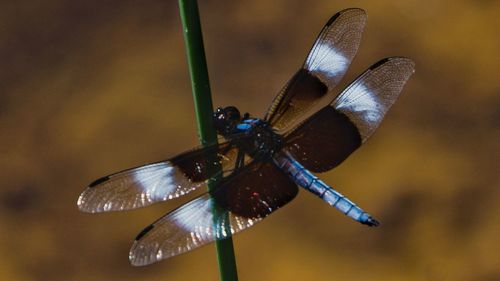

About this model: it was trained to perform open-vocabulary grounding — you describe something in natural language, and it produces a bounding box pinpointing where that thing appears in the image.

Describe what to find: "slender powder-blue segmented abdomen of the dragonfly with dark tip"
[274,153,379,226]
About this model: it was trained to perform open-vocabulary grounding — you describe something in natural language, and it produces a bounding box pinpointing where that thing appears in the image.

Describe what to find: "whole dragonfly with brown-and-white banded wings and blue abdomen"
[77,8,415,266]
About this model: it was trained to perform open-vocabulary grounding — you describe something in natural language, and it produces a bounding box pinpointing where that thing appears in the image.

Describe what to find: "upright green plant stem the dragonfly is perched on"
[179,0,238,281]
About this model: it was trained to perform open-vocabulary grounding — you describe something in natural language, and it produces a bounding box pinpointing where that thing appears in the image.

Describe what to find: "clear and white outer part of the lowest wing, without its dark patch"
[129,193,260,266]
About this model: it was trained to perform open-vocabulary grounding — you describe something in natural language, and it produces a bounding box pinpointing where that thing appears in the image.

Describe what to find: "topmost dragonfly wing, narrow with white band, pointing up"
[265,8,366,130]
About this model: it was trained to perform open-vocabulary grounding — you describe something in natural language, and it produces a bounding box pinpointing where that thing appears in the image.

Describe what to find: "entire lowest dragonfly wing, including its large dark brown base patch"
[129,162,298,266]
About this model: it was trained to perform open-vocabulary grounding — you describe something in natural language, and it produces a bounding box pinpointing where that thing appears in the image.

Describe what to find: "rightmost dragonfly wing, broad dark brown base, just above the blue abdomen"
[286,57,415,172]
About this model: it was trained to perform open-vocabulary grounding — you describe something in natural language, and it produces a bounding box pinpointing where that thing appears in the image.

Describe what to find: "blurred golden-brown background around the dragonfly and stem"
[0,0,500,281]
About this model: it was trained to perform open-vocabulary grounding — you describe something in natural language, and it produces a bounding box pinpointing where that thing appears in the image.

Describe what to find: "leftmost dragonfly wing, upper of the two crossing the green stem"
[77,142,237,213]
